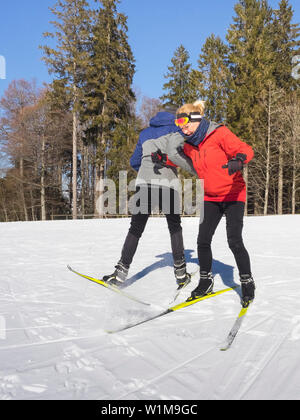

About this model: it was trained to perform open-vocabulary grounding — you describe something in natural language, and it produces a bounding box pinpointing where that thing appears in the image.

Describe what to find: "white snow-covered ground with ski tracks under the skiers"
[0,215,300,400]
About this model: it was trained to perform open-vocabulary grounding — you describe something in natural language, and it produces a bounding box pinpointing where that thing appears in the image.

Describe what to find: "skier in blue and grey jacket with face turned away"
[103,112,195,288]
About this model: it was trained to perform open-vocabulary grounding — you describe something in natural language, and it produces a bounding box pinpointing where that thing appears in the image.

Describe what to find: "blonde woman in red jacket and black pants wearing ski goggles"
[167,101,255,306]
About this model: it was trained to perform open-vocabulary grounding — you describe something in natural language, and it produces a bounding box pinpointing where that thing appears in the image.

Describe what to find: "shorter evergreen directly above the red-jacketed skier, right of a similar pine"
[198,34,230,122]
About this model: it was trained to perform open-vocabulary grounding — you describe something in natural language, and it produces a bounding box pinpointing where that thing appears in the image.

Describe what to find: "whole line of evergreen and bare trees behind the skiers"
[0,0,300,221]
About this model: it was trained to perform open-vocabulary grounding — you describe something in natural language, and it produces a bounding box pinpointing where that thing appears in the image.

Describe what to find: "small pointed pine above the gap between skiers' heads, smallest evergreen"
[160,45,193,108]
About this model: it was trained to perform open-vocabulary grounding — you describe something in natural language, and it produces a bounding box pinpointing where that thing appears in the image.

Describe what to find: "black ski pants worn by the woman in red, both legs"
[197,201,251,275]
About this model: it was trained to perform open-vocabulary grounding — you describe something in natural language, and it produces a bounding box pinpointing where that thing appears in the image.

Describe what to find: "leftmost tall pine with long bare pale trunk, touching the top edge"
[42,0,90,219]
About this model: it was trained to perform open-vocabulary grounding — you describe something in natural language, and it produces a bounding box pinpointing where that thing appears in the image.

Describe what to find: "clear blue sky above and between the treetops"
[0,0,300,98]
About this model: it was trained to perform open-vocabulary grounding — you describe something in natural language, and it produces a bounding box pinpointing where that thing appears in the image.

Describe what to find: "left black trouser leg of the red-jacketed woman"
[197,201,223,273]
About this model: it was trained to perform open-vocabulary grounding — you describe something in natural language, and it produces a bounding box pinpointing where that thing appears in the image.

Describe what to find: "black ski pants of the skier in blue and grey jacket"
[121,185,185,267]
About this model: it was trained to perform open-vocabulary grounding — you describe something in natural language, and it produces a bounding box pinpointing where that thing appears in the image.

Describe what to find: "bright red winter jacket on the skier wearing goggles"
[184,126,254,202]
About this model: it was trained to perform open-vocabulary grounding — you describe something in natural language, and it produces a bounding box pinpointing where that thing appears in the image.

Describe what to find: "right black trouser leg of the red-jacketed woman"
[225,201,251,276]
